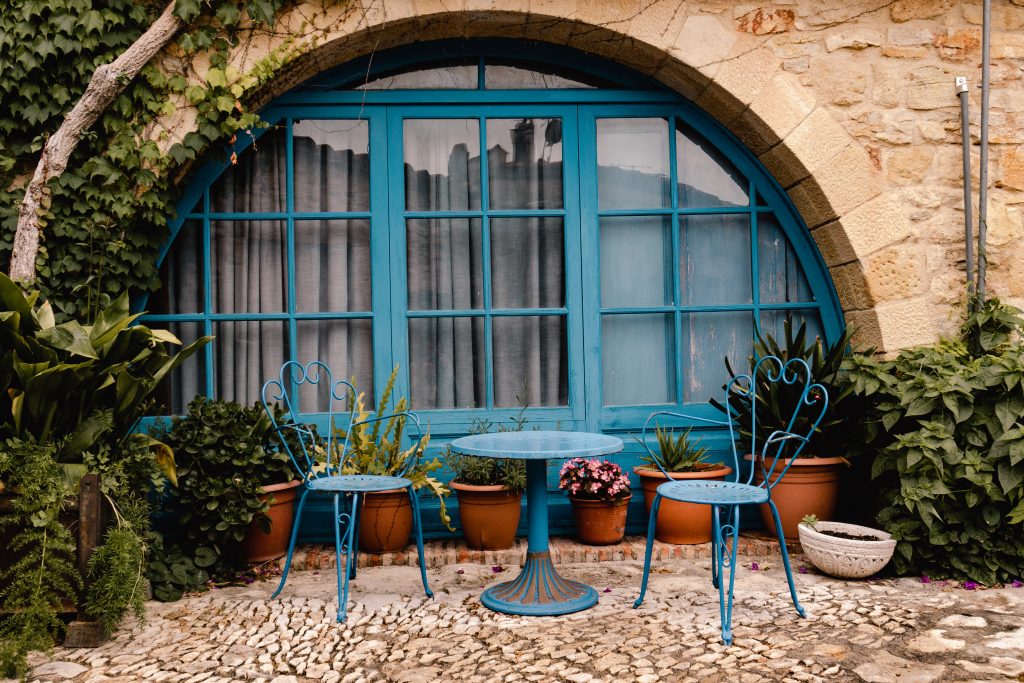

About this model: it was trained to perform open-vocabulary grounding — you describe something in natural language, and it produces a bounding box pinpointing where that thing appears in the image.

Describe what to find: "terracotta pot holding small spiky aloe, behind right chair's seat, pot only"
[633,465,732,545]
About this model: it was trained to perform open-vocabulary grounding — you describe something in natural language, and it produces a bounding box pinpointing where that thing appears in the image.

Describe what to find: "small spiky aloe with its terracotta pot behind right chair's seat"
[633,427,732,545]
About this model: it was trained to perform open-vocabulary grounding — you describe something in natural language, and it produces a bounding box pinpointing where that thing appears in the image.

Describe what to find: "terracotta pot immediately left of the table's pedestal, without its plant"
[449,481,522,550]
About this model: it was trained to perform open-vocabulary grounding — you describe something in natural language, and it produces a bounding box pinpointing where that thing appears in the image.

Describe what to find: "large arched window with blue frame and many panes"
[146,42,843,448]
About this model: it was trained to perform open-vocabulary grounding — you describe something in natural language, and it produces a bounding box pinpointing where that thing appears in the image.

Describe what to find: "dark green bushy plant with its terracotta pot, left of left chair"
[157,396,301,565]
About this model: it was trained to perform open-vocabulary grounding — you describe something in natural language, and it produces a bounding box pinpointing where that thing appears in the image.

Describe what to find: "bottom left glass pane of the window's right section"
[601,313,676,405]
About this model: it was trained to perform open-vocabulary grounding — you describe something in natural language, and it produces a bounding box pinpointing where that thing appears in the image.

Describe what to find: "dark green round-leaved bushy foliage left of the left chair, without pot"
[150,396,297,599]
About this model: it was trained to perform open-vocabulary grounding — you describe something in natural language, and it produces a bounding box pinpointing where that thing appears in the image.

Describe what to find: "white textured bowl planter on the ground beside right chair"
[798,521,896,579]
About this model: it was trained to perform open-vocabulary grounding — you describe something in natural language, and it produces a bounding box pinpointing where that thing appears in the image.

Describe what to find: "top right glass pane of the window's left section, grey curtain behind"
[292,120,370,211]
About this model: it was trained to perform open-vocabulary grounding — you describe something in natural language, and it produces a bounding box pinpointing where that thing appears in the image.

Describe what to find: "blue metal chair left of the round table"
[261,360,434,622]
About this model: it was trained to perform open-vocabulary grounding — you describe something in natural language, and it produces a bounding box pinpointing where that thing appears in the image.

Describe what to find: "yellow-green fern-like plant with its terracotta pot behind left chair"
[334,366,455,553]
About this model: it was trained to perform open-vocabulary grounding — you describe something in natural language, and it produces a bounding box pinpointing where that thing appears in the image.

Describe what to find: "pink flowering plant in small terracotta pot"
[558,458,633,546]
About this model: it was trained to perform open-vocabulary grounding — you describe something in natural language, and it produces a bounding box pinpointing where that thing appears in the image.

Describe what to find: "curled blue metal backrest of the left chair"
[260,360,355,480]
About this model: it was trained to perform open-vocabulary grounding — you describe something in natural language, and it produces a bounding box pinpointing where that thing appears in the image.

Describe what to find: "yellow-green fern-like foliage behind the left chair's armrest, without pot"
[334,366,455,530]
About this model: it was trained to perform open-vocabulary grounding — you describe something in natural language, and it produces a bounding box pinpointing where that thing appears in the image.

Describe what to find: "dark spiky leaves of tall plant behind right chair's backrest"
[710,317,861,458]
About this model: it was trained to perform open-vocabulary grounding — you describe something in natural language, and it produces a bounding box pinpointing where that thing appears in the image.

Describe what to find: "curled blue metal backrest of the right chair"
[725,355,828,490]
